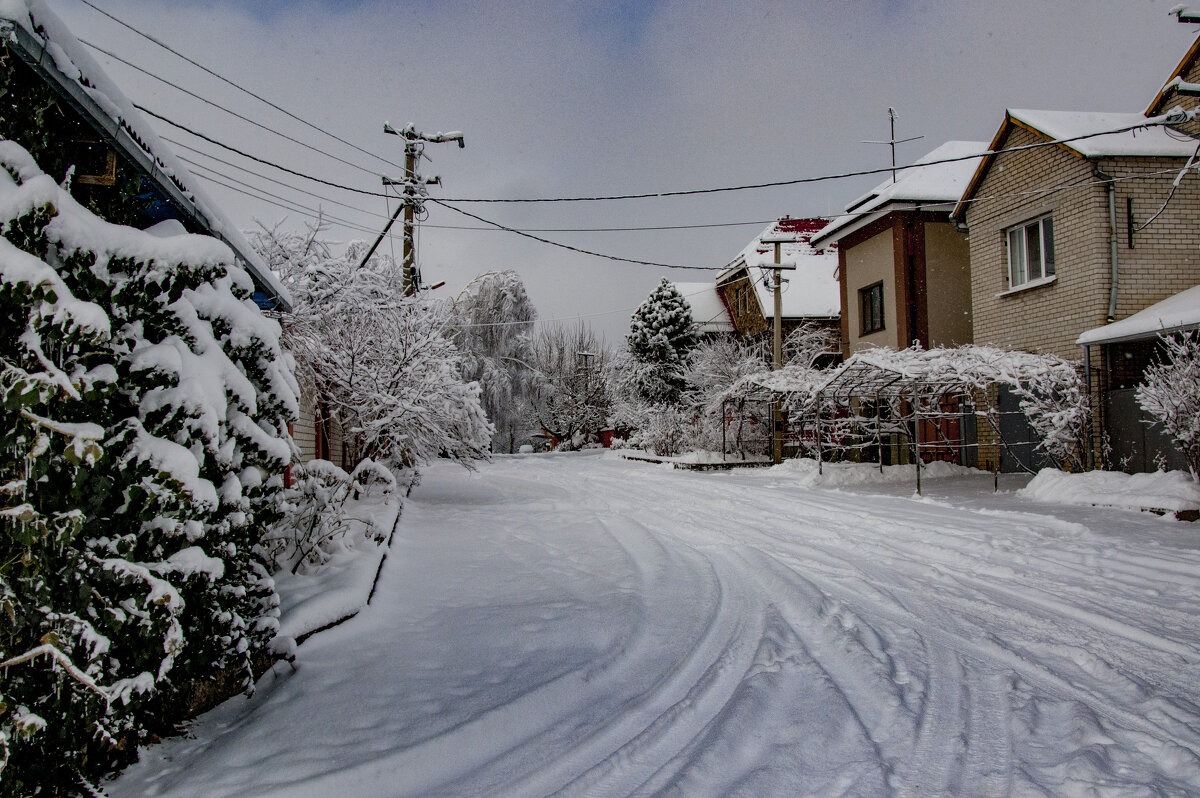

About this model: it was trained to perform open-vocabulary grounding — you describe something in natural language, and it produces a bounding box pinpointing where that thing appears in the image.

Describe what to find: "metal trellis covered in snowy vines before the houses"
[763,346,1088,490]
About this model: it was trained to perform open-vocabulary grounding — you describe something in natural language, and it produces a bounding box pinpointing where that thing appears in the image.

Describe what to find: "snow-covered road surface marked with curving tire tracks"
[109,452,1200,798]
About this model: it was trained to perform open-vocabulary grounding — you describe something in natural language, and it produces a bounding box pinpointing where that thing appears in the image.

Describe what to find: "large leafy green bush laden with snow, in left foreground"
[0,142,296,794]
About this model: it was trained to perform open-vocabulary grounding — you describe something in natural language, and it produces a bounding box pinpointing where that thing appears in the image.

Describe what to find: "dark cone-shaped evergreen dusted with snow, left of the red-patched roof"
[623,277,700,404]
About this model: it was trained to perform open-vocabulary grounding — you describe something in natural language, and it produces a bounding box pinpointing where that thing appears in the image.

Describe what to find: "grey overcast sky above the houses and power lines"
[47,0,1196,343]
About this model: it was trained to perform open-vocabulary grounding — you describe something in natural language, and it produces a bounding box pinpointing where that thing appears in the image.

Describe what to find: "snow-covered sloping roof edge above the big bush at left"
[0,0,292,311]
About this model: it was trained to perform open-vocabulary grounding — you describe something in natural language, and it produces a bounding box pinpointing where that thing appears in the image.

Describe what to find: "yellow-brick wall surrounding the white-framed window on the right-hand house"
[966,128,1200,360]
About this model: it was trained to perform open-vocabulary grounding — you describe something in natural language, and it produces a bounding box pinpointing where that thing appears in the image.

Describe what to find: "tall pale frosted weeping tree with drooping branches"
[454,270,538,452]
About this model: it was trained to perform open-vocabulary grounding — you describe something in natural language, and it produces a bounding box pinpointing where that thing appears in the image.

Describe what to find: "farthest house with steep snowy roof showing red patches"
[716,216,841,341]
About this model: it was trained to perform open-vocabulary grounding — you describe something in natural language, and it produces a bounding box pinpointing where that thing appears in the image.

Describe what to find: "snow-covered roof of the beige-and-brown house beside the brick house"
[812,142,988,246]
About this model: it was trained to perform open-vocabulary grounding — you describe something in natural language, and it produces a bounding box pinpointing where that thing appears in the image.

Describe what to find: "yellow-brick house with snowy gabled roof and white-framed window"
[953,97,1200,468]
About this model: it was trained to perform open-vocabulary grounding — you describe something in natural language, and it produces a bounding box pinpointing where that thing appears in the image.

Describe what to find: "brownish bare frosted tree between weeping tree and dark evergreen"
[530,322,611,449]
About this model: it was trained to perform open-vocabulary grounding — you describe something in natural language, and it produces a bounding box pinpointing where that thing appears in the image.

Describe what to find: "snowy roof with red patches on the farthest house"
[716,217,841,319]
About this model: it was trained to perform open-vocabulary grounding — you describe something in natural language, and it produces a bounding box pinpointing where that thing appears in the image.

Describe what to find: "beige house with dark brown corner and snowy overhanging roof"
[811,142,986,356]
